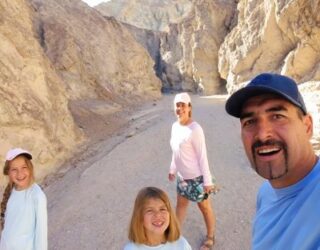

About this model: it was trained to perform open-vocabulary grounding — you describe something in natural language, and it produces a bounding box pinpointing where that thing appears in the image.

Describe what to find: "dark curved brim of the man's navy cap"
[225,86,305,118]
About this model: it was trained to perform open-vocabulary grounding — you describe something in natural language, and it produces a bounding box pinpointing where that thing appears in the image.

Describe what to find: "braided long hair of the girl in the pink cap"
[0,154,34,229]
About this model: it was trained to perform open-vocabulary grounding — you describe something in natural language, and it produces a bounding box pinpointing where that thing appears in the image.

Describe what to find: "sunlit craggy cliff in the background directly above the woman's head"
[161,0,235,94]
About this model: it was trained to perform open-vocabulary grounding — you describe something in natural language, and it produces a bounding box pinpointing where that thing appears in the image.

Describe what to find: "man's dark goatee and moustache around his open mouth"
[251,140,289,180]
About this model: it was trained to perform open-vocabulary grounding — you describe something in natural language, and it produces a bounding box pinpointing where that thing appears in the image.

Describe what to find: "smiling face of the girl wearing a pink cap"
[8,156,31,190]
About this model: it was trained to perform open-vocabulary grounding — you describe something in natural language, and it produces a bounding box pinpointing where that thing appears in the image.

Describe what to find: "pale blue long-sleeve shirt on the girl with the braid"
[0,183,48,250]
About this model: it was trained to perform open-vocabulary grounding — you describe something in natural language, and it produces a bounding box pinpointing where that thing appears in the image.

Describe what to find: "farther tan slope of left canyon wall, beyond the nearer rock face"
[32,0,161,101]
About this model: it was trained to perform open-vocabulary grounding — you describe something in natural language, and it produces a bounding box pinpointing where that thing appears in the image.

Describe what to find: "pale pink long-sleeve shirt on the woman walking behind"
[170,121,212,186]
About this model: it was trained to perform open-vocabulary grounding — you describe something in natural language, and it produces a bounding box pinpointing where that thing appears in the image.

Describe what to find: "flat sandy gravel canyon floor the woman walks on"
[44,95,262,250]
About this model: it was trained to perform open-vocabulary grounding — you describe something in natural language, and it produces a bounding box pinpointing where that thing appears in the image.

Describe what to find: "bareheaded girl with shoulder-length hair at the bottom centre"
[124,187,191,250]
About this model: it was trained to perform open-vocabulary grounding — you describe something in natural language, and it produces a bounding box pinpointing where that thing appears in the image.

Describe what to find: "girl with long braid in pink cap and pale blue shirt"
[0,148,48,250]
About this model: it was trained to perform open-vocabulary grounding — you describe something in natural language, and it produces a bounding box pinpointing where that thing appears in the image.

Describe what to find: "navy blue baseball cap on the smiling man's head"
[225,73,307,118]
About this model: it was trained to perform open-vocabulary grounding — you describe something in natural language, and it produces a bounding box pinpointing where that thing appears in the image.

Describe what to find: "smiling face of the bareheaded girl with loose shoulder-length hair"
[143,199,170,241]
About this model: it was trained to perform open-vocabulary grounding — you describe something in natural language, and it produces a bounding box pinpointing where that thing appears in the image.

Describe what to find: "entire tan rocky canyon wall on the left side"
[0,0,161,183]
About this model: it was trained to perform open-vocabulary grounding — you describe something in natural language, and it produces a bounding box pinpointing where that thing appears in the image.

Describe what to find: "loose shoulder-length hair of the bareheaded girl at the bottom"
[128,187,180,244]
